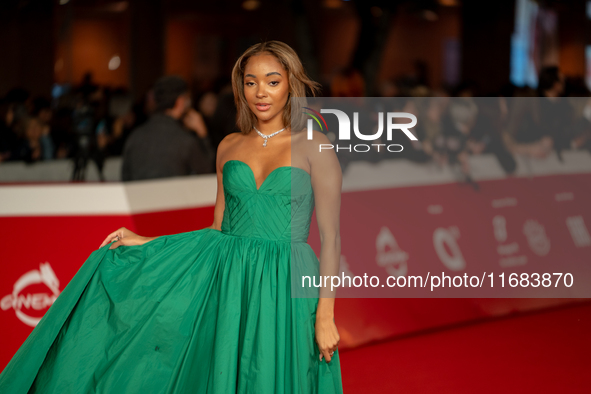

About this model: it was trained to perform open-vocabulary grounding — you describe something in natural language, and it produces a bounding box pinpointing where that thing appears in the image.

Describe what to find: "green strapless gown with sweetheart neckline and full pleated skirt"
[0,160,342,394]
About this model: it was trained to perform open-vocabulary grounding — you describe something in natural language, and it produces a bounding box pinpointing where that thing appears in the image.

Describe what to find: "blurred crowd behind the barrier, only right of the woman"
[329,67,591,179]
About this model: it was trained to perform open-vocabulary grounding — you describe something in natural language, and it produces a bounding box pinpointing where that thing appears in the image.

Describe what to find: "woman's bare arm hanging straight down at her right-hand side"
[307,132,342,362]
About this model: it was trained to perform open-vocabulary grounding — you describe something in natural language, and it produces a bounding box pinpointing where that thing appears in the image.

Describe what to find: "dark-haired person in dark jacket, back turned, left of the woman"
[121,76,214,181]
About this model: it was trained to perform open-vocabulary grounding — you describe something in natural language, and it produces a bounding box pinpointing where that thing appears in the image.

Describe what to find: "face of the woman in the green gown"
[244,54,289,122]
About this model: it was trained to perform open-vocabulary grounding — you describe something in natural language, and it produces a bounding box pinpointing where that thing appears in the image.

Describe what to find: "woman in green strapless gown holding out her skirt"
[0,41,342,394]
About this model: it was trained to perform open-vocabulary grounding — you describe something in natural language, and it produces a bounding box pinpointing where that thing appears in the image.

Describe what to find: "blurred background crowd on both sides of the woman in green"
[0,67,591,179]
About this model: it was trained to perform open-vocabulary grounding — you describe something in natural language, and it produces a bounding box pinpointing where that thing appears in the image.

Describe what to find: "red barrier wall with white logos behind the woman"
[0,158,591,368]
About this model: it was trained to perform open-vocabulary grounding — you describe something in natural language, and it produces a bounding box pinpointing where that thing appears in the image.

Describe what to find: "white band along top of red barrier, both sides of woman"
[0,151,591,216]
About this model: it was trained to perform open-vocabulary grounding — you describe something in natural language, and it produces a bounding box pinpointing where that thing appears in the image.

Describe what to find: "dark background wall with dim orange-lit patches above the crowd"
[0,0,591,96]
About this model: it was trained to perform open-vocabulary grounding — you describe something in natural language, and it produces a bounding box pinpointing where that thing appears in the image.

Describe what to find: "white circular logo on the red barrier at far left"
[0,262,60,327]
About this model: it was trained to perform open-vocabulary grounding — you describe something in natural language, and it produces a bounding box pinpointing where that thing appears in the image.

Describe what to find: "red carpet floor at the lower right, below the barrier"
[337,302,591,394]
